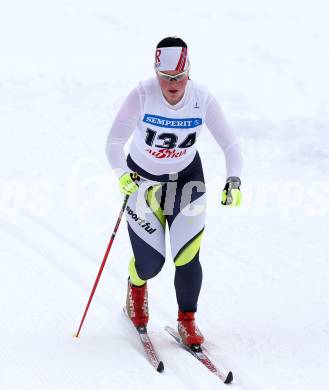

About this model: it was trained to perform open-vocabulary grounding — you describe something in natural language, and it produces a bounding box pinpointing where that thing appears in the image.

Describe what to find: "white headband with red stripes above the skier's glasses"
[155,47,189,72]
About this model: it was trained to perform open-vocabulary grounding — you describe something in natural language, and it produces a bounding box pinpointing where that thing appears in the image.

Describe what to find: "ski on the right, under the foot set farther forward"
[165,326,233,384]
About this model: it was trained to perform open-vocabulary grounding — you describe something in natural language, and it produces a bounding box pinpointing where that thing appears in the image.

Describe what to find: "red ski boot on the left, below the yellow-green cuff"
[126,279,149,327]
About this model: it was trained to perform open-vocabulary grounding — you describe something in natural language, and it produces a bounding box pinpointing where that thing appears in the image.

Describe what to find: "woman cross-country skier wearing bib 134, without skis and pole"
[106,37,242,345]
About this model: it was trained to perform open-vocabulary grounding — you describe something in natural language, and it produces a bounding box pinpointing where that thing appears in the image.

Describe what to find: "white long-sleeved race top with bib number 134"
[106,77,242,177]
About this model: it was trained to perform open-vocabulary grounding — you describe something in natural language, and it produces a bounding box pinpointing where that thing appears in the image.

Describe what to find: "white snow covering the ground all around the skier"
[0,0,329,390]
